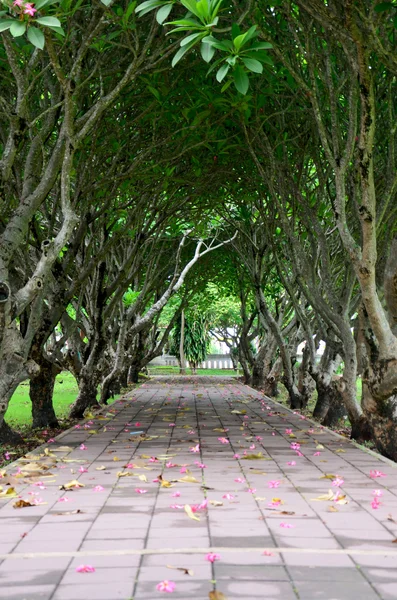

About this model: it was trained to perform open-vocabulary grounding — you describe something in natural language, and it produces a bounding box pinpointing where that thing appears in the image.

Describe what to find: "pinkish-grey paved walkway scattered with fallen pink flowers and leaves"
[0,377,397,600]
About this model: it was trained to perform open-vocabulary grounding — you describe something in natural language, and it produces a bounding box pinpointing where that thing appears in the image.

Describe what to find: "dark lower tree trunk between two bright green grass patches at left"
[29,356,61,429]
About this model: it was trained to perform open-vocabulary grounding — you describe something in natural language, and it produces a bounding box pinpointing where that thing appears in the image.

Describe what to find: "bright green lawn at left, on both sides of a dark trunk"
[6,371,79,429]
